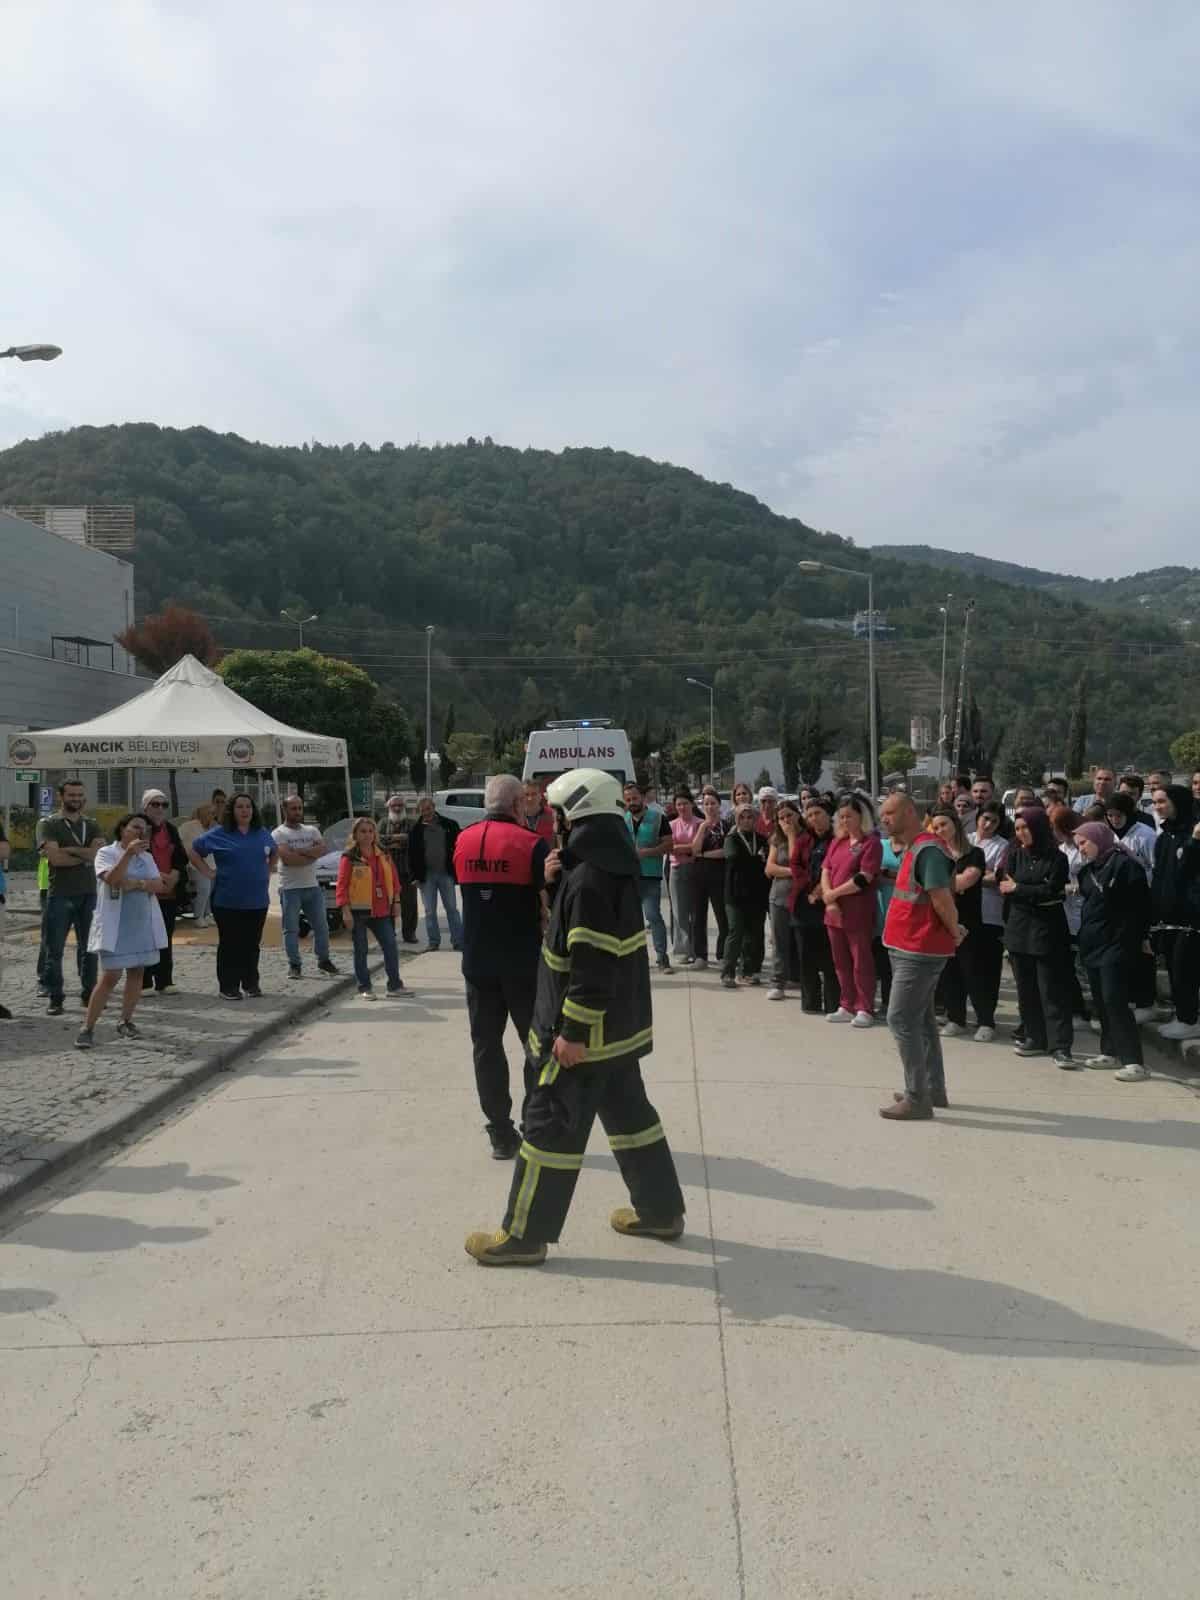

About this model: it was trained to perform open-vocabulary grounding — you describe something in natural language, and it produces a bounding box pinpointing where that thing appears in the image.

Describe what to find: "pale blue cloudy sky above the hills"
[0,0,1200,576]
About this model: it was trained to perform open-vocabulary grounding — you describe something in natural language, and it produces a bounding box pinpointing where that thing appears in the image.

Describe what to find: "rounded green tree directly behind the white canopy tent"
[216,650,411,776]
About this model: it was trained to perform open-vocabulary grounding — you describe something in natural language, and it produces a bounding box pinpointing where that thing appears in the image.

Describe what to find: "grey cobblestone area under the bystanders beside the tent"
[0,874,387,1202]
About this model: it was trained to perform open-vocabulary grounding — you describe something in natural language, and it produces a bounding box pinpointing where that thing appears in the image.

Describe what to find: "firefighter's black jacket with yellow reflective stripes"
[528,816,651,1083]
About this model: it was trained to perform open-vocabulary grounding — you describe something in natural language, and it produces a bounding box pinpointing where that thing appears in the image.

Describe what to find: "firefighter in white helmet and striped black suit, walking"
[467,768,683,1267]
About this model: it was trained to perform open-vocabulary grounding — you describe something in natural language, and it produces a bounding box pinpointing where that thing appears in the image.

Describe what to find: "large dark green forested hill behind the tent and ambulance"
[0,424,1197,762]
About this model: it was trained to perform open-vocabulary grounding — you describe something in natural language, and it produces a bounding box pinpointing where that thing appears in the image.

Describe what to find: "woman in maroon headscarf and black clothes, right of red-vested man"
[997,806,1077,1070]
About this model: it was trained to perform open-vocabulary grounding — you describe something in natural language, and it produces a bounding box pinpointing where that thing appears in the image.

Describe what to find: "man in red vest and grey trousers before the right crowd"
[880,794,966,1122]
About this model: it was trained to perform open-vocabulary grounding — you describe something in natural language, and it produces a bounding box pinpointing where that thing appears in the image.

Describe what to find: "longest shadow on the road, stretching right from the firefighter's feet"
[547,1235,1200,1363]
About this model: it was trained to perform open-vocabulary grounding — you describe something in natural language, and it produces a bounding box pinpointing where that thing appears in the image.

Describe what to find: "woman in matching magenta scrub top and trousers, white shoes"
[821,795,883,1027]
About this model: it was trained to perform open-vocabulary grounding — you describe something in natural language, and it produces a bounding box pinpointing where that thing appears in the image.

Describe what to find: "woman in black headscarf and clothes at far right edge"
[1150,784,1200,1038]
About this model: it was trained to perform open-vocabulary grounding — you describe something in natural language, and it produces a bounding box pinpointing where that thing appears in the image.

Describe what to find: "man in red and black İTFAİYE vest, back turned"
[454,776,549,1162]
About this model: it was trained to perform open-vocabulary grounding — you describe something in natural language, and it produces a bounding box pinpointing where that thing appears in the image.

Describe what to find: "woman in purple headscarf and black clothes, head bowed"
[1075,822,1150,1083]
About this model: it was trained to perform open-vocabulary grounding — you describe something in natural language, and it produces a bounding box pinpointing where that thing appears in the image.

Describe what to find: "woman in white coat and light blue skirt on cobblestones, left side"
[75,811,166,1050]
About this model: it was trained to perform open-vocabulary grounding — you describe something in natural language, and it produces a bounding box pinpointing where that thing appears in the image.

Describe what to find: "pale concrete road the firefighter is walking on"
[0,954,1200,1600]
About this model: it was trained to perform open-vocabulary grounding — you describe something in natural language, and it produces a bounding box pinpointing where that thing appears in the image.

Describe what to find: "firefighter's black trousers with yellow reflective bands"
[504,1061,683,1245]
